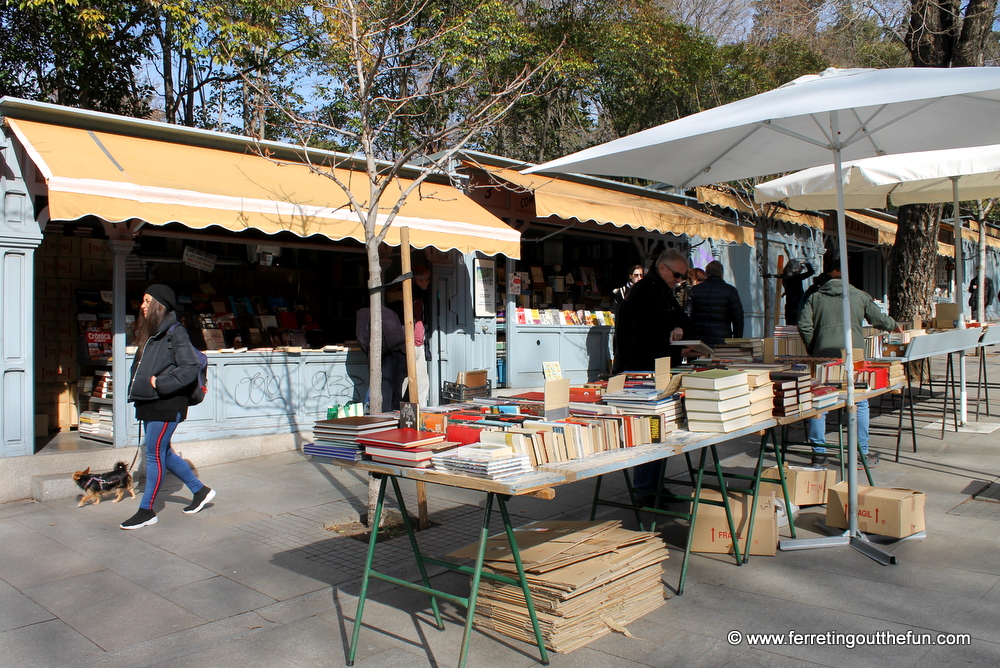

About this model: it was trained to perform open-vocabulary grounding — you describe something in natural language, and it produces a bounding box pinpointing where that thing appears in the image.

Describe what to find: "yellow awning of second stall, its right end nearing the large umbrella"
[488,165,754,246]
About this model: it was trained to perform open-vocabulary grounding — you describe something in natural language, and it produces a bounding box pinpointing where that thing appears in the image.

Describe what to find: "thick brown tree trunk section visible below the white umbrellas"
[889,204,941,321]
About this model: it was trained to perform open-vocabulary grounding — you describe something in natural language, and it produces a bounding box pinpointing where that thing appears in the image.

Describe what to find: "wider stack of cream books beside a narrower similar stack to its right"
[681,369,752,433]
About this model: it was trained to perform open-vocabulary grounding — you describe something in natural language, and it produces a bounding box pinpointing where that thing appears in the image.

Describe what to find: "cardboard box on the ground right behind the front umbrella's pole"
[826,481,927,538]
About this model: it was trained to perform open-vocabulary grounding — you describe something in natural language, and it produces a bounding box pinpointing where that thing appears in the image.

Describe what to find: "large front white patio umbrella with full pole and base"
[526,67,1000,563]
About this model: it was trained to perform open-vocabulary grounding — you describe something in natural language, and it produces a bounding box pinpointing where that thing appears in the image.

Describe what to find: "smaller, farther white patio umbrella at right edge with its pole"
[754,144,1000,424]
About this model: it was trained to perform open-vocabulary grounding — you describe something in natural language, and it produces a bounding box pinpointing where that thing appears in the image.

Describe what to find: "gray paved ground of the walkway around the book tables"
[0,358,1000,668]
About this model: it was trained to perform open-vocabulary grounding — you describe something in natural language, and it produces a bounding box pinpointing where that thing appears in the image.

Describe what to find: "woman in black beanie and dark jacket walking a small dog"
[120,284,215,529]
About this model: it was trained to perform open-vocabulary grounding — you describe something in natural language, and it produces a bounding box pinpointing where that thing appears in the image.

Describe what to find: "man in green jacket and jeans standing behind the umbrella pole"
[799,256,899,468]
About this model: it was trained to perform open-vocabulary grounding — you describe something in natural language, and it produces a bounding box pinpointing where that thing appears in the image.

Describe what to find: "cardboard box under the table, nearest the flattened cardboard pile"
[691,489,778,557]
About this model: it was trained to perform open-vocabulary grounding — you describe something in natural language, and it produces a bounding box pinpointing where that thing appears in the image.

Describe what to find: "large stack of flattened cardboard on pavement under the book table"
[448,521,669,652]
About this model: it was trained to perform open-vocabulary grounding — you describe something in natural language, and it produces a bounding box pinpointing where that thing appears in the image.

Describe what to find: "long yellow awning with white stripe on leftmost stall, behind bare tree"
[6,117,521,258]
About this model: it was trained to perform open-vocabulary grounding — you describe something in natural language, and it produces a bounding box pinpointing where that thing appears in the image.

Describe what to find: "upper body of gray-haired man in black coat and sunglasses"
[614,248,691,373]
